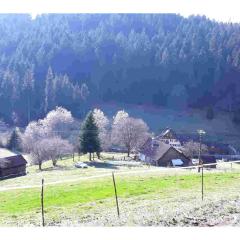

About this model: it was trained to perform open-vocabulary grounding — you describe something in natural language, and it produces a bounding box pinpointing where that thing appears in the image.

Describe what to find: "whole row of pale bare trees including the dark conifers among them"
[4,107,151,170]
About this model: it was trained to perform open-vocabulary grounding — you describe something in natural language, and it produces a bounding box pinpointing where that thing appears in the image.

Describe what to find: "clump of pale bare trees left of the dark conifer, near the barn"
[22,107,73,170]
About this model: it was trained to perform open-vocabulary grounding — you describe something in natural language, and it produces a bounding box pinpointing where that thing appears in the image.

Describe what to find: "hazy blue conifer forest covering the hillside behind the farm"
[0,14,240,125]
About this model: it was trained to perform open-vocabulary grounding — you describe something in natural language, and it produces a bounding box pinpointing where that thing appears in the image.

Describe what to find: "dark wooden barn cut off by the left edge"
[0,155,27,179]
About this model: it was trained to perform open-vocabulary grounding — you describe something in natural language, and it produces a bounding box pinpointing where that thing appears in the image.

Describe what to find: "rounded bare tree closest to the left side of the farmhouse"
[112,117,149,156]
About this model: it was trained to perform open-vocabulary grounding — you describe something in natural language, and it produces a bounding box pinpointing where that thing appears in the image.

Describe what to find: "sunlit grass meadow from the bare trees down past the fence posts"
[0,150,240,226]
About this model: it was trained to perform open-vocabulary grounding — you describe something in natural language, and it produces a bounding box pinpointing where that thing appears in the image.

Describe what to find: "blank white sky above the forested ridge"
[0,0,240,23]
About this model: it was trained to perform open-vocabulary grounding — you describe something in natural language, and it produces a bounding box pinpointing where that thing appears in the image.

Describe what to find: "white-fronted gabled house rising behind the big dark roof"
[155,128,182,150]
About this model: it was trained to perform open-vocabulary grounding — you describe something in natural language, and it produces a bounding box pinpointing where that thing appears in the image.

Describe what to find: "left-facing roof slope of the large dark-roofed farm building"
[140,138,172,160]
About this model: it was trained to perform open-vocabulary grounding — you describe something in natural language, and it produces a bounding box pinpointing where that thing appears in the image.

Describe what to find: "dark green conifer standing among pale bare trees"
[79,111,101,161]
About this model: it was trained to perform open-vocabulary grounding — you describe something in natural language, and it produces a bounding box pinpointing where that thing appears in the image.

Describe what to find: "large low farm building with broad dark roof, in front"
[139,138,192,167]
